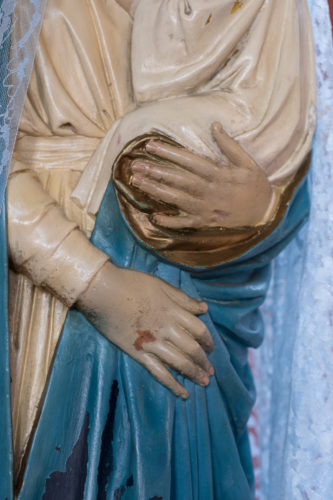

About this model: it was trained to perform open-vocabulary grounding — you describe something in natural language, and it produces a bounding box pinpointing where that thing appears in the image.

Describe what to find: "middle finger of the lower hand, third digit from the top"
[168,327,215,375]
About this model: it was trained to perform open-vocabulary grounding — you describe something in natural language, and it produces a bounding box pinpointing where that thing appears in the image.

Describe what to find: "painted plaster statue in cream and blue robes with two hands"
[7,0,315,500]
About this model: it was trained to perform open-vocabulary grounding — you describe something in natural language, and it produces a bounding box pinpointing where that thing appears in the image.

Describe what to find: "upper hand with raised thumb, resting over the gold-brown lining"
[131,123,272,229]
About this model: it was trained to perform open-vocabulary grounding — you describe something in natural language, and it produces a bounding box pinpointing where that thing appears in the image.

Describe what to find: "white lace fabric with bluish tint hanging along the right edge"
[255,0,333,500]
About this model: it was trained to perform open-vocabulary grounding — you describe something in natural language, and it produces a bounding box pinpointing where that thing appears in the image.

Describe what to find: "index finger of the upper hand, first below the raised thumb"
[146,141,216,180]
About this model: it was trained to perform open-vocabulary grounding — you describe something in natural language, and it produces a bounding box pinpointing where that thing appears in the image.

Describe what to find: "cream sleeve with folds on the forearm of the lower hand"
[7,170,108,307]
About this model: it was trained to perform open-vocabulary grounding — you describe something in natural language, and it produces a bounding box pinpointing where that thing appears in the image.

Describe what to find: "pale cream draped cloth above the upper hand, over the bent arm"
[73,0,316,217]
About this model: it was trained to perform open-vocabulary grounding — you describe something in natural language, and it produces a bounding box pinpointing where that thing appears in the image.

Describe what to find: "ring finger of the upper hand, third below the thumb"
[132,174,195,211]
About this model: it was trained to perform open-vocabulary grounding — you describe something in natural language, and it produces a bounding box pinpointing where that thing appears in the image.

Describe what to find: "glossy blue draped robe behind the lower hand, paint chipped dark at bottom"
[0,170,309,500]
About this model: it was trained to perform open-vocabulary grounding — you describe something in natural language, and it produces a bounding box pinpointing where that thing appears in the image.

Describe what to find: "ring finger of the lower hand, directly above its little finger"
[145,341,209,387]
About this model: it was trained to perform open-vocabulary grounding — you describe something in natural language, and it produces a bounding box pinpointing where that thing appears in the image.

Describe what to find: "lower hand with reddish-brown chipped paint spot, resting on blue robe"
[77,262,214,398]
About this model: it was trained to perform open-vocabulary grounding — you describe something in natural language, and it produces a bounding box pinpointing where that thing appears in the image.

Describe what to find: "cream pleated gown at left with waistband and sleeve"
[8,0,132,484]
